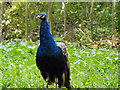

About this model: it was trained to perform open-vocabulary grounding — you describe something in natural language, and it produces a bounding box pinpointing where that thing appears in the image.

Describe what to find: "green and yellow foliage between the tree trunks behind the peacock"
[2,2,120,42]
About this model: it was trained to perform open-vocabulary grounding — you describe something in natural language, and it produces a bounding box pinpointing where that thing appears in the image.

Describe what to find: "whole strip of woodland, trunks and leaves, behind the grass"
[0,2,120,48]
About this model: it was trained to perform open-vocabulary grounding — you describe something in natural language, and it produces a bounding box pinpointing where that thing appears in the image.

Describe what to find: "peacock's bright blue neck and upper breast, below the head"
[40,19,60,55]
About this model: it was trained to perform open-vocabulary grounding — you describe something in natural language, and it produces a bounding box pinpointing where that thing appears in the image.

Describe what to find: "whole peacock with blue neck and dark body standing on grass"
[36,13,71,89]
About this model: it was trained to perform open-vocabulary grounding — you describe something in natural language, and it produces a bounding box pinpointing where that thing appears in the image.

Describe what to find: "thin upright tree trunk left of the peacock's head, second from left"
[25,0,28,40]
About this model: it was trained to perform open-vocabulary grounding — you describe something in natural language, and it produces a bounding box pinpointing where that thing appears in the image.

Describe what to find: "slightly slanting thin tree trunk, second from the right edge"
[90,0,94,41]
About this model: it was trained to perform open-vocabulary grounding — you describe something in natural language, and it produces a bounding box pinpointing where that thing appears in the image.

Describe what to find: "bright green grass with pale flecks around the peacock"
[0,40,118,88]
